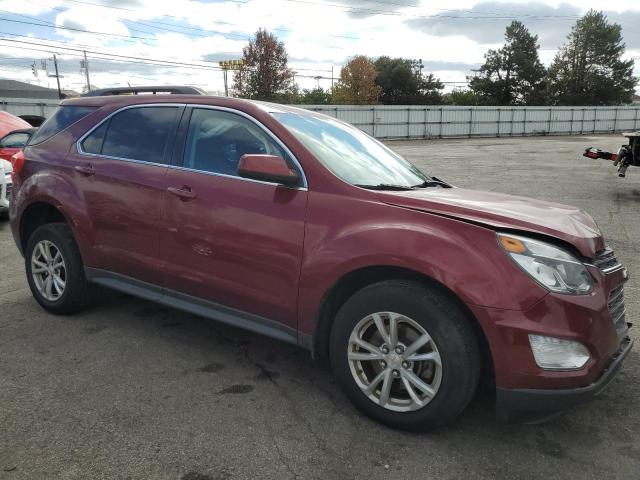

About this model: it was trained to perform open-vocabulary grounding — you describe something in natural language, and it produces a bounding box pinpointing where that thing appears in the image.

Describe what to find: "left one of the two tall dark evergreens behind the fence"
[469,21,545,105]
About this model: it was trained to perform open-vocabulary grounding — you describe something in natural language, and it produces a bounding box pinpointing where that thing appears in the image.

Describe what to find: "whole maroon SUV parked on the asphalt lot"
[10,95,632,430]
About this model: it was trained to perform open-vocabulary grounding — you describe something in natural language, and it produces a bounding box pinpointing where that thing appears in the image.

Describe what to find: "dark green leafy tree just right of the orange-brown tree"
[374,57,444,105]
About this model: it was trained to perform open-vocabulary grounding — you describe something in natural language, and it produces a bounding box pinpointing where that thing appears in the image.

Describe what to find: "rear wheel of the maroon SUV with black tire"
[25,223,91,315]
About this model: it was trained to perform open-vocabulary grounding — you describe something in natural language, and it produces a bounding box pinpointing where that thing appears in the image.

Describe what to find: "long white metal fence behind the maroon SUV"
[0,99,640,139]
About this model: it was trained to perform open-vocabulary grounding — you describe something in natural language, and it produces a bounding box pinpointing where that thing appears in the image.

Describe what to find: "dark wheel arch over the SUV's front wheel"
[313,265,493,377]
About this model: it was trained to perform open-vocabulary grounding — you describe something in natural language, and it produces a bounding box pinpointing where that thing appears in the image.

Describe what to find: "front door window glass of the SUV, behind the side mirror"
[183,108,287,176]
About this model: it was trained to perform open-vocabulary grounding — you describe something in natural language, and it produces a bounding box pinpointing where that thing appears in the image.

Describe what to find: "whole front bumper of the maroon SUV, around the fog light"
[470,260,632,421]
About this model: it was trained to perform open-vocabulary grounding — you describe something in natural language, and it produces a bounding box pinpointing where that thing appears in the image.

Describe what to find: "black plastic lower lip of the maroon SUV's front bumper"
[496,337,633,422]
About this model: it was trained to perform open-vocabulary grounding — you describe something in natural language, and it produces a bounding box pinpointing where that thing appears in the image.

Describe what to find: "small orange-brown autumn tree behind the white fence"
[333,55,382,105]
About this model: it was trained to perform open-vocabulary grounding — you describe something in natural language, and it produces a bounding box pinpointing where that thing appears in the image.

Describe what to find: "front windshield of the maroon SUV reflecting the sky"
[273,112,431,187]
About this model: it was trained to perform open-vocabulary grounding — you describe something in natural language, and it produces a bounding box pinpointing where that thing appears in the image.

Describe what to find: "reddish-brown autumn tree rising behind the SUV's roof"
[233,29,296,101]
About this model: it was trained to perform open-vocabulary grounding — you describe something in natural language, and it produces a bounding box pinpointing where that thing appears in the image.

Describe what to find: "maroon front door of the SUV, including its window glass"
[160,108,307,327]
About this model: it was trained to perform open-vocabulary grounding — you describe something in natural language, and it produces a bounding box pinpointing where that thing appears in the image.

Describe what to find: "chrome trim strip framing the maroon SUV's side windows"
[76,103,308,191]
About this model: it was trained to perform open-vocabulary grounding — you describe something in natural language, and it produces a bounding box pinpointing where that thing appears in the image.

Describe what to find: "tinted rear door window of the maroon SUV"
[82,106,179,164]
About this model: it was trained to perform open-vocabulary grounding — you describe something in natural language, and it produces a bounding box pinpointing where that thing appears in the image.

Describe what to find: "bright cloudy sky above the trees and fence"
[0,0,640,94]
